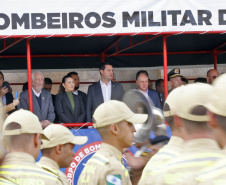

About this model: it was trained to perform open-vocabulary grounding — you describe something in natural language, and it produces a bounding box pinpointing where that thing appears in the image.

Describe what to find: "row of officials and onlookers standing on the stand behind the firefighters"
[0,63,219,125]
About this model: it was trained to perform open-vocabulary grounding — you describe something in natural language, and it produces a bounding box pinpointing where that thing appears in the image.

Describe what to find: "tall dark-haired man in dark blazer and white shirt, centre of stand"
[86,62,124,122]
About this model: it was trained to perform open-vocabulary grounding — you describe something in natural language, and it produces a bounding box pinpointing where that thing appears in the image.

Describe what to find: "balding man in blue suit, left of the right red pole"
[136,70,161,109]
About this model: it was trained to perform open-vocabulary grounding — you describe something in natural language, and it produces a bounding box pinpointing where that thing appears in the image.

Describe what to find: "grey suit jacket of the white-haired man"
[20,89,55,123]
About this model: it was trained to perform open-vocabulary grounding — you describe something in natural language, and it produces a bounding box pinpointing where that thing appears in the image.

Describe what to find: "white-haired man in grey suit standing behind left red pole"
[20,72,55,128]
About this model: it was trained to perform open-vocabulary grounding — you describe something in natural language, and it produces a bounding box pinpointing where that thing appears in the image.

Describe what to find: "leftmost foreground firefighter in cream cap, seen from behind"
[0,109,61,185]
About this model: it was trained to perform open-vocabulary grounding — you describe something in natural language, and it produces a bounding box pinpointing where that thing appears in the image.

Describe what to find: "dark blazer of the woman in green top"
[55,92,86,123]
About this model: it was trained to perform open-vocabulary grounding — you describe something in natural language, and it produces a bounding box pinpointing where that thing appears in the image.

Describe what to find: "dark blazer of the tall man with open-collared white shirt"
[86,81,125,122]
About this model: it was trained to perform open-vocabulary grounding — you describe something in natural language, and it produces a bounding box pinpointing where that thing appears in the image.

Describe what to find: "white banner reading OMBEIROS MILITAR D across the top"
[0,0,226,35]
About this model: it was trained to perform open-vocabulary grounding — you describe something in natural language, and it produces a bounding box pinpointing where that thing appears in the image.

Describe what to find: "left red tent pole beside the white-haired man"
[26,39,33,112]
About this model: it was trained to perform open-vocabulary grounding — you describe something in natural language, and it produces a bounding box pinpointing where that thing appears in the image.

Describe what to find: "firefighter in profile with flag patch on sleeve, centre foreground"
[78,100,148,185]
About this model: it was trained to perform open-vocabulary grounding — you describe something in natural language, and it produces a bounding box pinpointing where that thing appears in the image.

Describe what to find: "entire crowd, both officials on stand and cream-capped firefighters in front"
[0,63,223,185]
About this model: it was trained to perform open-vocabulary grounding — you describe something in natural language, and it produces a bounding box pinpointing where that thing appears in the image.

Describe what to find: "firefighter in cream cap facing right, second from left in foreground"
[36,124,88,185]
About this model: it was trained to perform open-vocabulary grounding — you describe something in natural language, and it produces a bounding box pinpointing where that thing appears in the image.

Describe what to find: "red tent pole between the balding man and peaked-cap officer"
[162,36,168,99]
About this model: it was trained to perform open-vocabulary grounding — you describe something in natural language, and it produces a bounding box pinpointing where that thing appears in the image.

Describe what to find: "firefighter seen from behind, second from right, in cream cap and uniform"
[139,83,225,185]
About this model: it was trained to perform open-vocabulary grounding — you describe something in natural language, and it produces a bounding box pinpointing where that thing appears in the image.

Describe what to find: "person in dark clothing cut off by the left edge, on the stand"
[0,71,14,113]
